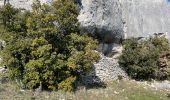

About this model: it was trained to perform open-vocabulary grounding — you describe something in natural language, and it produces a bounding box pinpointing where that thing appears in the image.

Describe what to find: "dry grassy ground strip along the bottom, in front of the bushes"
[0,80,170,100]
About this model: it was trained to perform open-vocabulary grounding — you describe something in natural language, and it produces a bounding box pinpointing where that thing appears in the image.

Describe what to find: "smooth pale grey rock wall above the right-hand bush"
[120,0,170,39]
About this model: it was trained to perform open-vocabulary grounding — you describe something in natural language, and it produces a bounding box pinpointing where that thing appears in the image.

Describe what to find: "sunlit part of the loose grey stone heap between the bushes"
[95,55,127,81]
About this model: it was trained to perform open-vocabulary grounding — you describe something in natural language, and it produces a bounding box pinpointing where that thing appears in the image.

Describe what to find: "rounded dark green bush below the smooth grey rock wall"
[119,36,170,80]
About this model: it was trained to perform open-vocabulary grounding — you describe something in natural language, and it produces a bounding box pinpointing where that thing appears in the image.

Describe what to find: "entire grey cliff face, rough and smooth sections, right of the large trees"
[78,0,170,42]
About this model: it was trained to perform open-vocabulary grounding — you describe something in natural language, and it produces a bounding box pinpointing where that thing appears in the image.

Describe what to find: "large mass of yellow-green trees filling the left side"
[0,0,99,91]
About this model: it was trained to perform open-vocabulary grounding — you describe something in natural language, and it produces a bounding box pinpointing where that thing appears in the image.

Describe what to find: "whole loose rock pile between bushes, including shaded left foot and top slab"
[83,45,128,84]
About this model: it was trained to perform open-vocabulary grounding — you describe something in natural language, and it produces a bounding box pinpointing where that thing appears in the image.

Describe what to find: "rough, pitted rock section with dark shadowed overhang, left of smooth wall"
[78,0,123,43]
